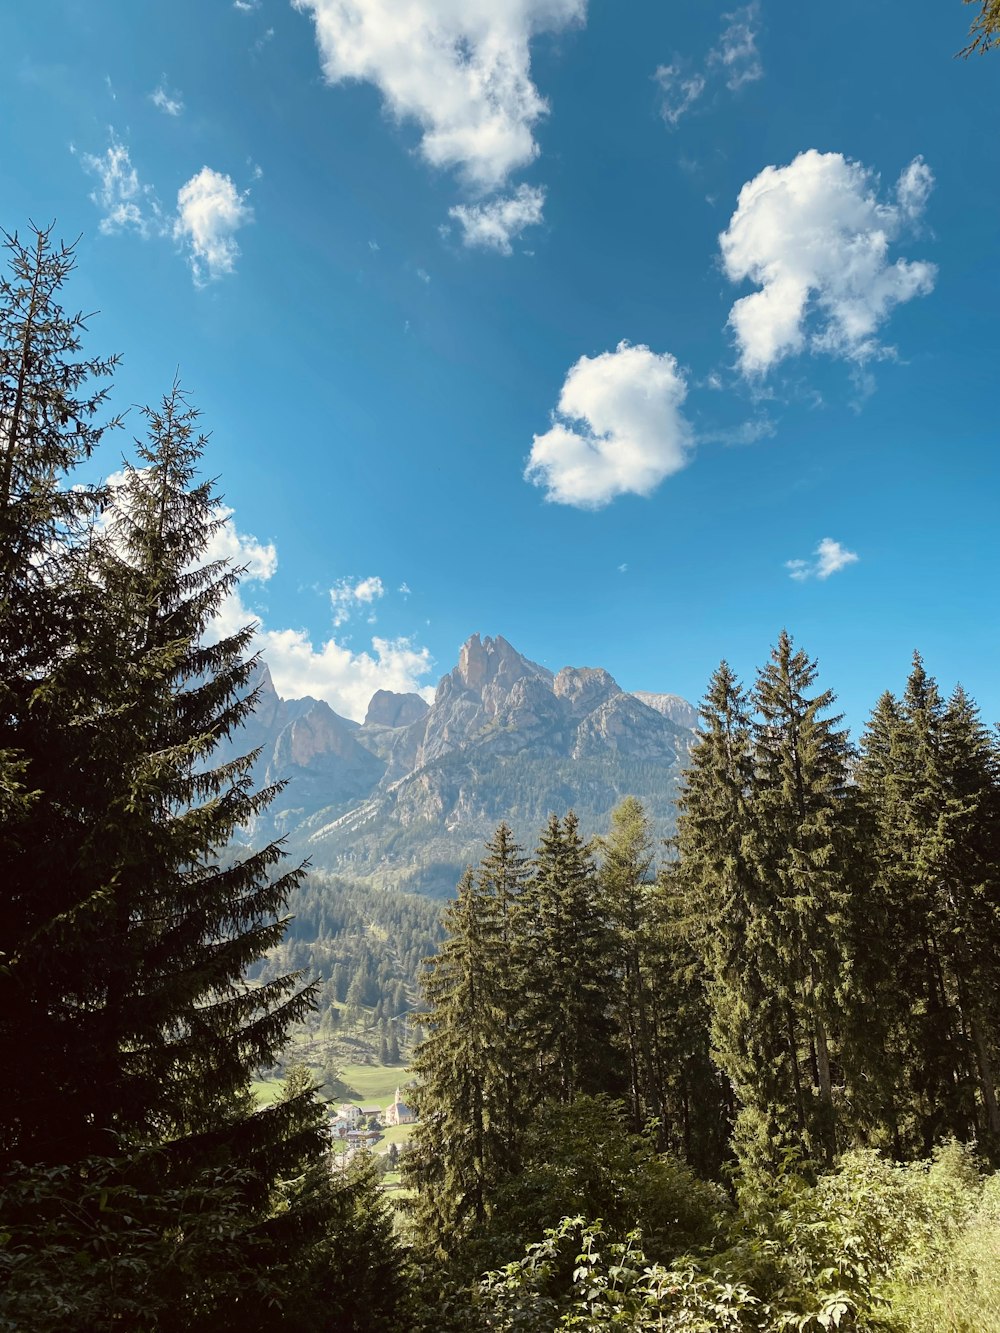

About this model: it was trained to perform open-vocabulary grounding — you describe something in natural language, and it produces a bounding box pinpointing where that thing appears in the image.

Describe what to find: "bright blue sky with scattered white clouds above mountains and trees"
[0,0,1000,733]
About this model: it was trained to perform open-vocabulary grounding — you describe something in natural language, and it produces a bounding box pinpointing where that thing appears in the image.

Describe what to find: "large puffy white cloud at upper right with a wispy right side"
[719,148,936,375]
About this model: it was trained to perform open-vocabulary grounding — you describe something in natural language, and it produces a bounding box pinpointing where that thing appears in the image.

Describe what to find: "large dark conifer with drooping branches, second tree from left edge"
[1,388,317,1178]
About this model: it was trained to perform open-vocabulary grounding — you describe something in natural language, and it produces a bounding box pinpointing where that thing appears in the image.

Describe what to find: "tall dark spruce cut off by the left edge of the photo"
[0,228,117,1162]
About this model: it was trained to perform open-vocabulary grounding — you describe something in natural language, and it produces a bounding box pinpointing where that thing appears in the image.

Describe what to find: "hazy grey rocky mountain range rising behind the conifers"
[223,635,697,894]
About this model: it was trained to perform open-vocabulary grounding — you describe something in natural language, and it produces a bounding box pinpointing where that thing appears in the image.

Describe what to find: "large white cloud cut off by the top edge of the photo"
[292,0,587,189]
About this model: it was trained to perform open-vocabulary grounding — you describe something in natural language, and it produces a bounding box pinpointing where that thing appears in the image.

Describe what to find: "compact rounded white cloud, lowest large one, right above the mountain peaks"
[524,343,691,509]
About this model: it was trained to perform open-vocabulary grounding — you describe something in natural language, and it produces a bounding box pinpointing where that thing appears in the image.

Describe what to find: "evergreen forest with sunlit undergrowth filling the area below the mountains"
[0,229,1000,1333]
